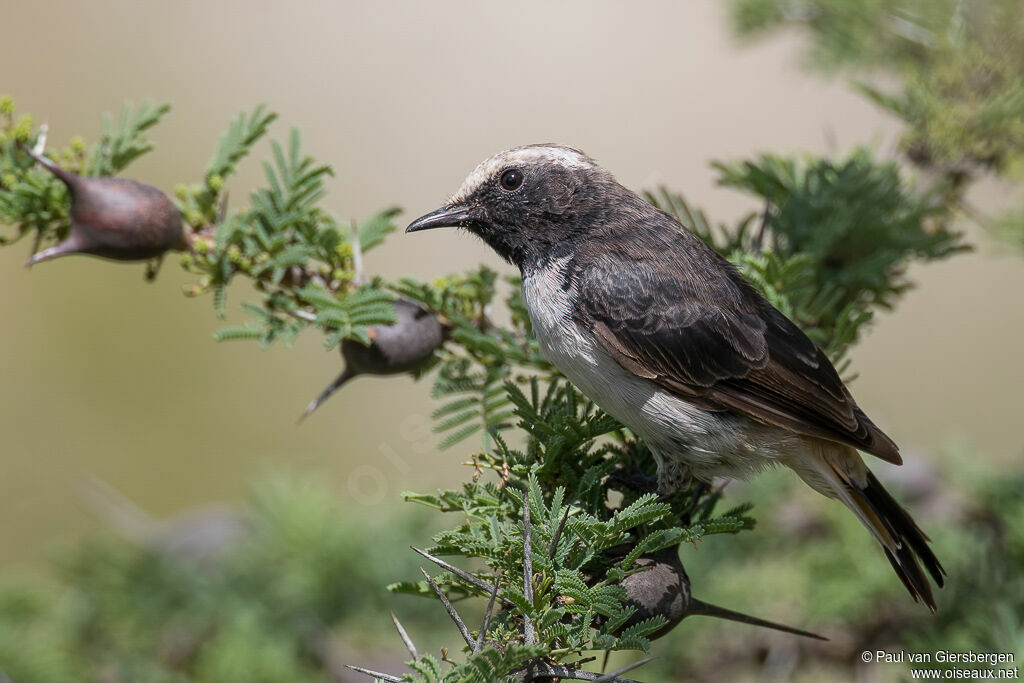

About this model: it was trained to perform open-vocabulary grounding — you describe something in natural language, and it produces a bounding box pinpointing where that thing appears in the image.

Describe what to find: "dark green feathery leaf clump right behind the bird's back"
[715,150,966,342]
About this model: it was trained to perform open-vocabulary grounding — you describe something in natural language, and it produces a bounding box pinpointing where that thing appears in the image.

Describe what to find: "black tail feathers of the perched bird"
[829,463,945,612]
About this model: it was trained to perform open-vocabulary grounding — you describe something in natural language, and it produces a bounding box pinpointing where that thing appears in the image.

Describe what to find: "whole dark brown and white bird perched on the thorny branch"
[407,144,944,611]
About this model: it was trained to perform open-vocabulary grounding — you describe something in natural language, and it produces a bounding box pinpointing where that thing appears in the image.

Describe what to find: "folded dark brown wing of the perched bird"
[573,250,901,464]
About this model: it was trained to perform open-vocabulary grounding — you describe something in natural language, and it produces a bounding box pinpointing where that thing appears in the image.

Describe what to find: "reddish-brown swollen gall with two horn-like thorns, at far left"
[22,146,185,265]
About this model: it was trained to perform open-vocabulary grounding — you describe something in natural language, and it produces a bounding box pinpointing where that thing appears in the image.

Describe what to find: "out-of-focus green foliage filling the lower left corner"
[0,474,450,683]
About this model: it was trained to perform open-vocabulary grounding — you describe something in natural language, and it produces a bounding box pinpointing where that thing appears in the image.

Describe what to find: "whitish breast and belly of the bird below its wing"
[522,257,796,489]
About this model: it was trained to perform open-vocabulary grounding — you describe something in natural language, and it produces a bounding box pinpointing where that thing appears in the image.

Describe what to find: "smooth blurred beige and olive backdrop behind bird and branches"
[0,0,1024,679]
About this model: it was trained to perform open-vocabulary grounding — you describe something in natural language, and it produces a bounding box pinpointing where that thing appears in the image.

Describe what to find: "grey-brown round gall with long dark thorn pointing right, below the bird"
[620,548,825,640]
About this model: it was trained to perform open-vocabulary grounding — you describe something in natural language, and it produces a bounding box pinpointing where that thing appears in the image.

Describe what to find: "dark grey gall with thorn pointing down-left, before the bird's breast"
[299,299,444,422]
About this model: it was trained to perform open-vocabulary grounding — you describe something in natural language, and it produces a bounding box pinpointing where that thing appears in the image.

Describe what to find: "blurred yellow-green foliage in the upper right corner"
[731,0,1024,252]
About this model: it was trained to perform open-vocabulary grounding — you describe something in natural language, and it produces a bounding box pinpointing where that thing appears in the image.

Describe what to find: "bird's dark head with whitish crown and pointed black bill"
[406,144,620,268]
